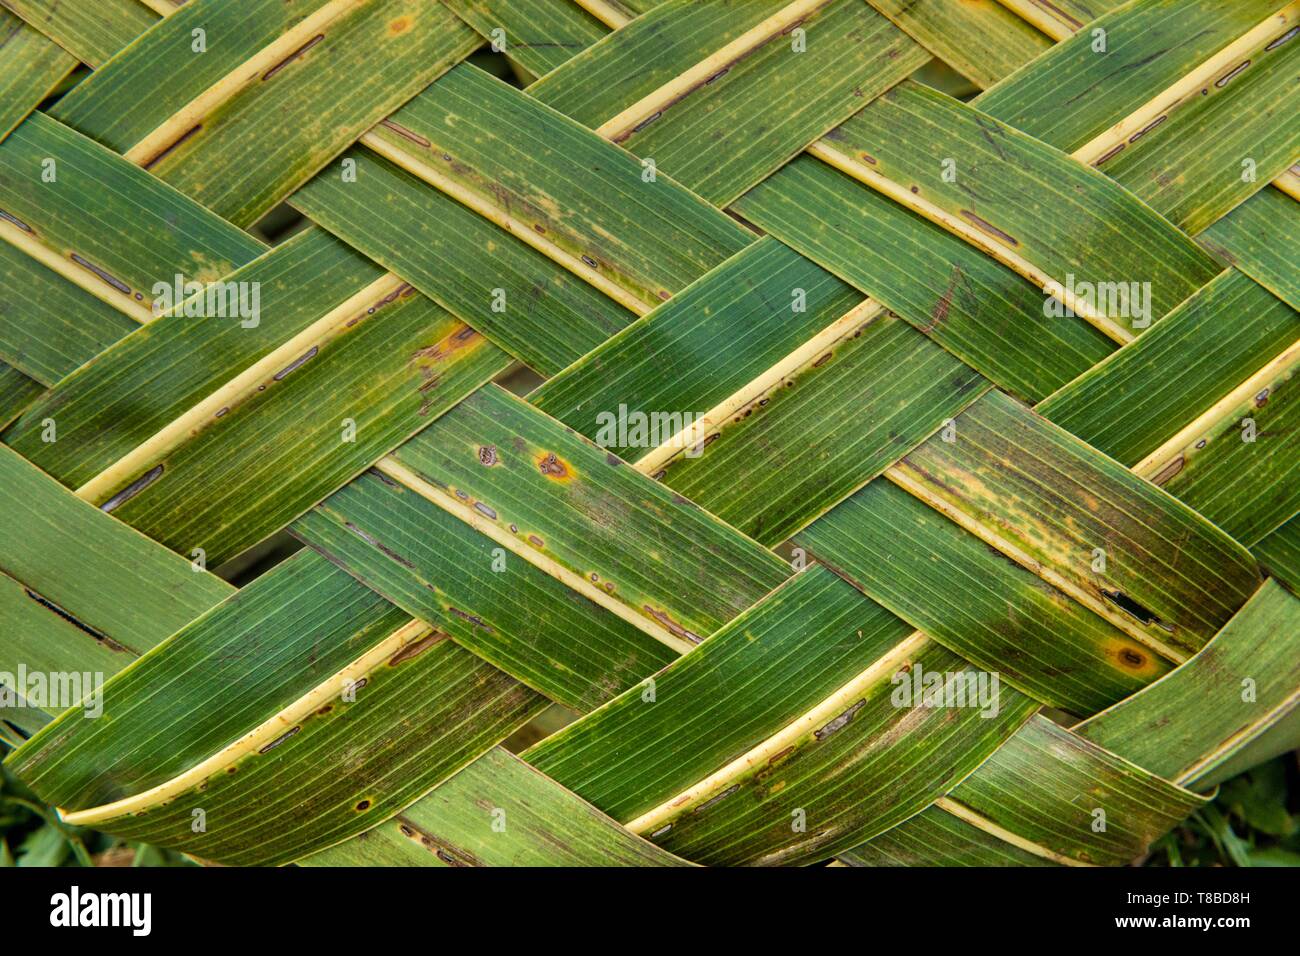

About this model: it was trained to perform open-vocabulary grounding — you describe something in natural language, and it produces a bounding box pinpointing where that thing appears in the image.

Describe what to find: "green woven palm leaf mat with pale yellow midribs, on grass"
[0,0,1300,866]
